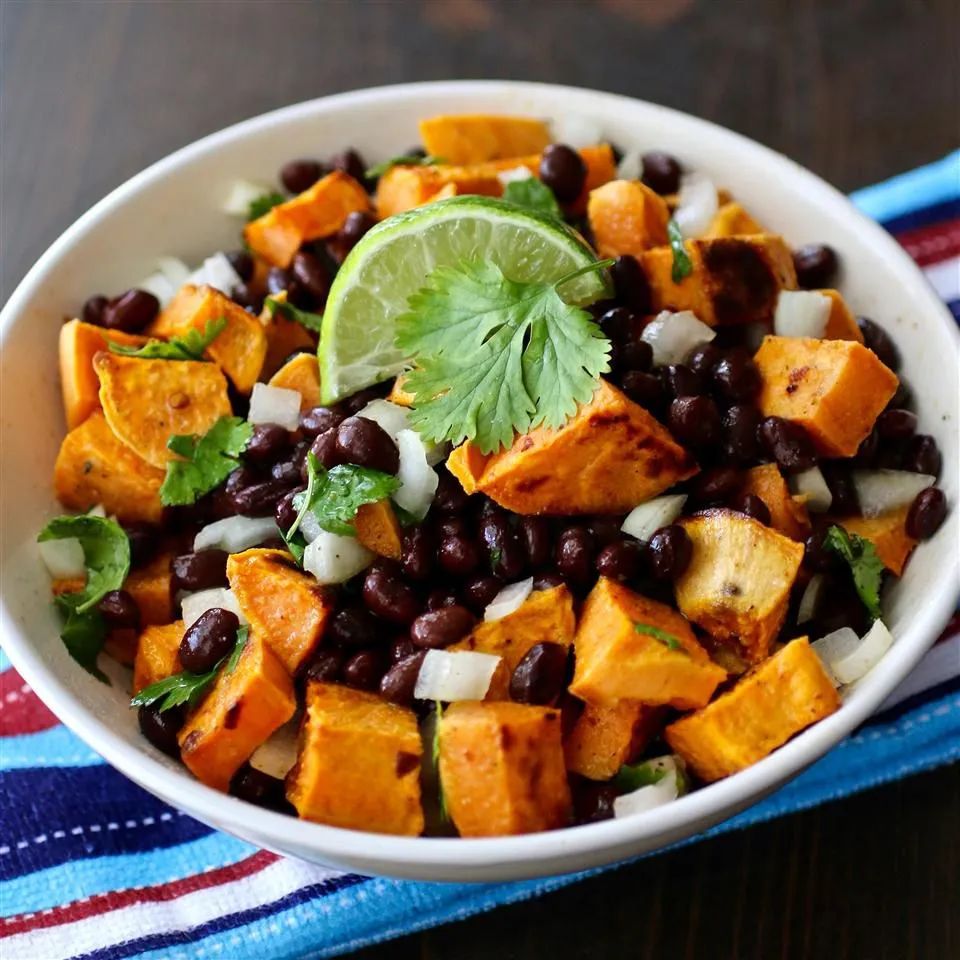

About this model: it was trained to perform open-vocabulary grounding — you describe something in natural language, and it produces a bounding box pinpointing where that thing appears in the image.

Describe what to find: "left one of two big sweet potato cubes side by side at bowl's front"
[287,682,423,837]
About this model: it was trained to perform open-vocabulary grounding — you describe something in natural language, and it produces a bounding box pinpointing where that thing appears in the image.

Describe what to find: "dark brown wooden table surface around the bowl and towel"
[0,0,960,960]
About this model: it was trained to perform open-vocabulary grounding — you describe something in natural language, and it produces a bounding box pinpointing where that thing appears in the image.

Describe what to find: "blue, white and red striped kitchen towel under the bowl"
[0,152,960,960]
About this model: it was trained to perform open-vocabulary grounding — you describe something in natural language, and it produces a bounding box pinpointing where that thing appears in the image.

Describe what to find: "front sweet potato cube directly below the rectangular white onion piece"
[440,701,570,837]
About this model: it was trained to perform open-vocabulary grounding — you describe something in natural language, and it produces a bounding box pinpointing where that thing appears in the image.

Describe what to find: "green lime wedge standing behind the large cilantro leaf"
[319,196,609,403]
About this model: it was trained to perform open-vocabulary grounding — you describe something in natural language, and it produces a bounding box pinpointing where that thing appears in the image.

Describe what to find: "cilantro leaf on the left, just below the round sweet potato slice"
[160,417,253,507]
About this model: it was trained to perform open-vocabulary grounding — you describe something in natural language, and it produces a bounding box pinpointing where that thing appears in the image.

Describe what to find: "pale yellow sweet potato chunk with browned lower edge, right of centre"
[674,509,803,663]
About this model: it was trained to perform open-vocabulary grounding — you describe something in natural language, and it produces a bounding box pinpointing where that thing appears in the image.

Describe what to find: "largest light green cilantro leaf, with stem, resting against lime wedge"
[396,260,611,453]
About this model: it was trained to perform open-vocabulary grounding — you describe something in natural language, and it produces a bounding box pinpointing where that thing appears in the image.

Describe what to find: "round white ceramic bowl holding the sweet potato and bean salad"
[0,82,960,880]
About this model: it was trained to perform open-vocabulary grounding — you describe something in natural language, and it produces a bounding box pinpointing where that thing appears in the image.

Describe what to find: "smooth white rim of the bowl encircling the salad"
[0,80,960,879]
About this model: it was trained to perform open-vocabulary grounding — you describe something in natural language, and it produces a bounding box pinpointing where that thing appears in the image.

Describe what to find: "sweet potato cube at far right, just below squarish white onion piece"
[754,337,899,457]
